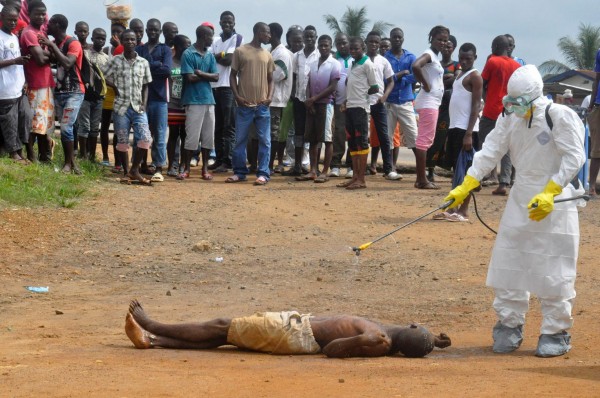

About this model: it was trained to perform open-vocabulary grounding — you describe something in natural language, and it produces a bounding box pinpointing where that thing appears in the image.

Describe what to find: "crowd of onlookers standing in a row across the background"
[0,0,596,198]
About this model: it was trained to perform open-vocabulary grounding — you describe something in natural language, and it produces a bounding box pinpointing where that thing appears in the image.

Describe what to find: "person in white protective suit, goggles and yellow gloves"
[445,65,585,357]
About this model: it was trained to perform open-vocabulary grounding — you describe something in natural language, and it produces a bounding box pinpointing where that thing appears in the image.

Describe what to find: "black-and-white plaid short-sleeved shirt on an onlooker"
[104,54,152,116]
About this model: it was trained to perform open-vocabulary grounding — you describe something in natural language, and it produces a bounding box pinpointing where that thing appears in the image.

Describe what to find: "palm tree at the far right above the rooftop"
[539,23,600,75]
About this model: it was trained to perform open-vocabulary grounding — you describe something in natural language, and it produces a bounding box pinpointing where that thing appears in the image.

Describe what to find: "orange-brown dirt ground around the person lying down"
[0,169,600,397]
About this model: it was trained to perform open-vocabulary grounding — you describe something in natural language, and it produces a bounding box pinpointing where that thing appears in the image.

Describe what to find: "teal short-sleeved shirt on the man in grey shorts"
[181,45,217,105]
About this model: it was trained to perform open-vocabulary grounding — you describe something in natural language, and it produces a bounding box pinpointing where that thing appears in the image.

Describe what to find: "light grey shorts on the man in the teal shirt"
[184,105,215,151]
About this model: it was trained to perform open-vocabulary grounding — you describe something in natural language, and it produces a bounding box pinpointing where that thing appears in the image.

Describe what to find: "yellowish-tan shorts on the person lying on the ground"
[227,311,321,355]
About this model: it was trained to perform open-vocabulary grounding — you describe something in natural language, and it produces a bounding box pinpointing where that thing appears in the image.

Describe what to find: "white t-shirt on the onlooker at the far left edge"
[0,30,25,99]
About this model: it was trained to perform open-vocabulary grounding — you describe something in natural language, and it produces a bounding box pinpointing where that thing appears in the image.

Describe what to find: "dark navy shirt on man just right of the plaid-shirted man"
[135,43,173,102]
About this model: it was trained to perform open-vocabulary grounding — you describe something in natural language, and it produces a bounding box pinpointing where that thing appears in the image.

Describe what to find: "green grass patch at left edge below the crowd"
[0,143,107,208]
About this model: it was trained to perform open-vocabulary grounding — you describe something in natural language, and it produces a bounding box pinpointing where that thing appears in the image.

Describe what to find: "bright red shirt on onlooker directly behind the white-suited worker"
[481,54,521,120]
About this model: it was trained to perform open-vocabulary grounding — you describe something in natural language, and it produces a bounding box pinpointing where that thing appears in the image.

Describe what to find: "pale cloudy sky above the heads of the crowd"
[45,0,600,69]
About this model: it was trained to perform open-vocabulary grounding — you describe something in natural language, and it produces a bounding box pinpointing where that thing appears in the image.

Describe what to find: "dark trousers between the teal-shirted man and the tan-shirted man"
[213,87,235,167]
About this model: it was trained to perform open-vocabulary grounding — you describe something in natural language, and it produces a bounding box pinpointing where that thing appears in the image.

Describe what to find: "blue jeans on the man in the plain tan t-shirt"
[232,105,271,180]
